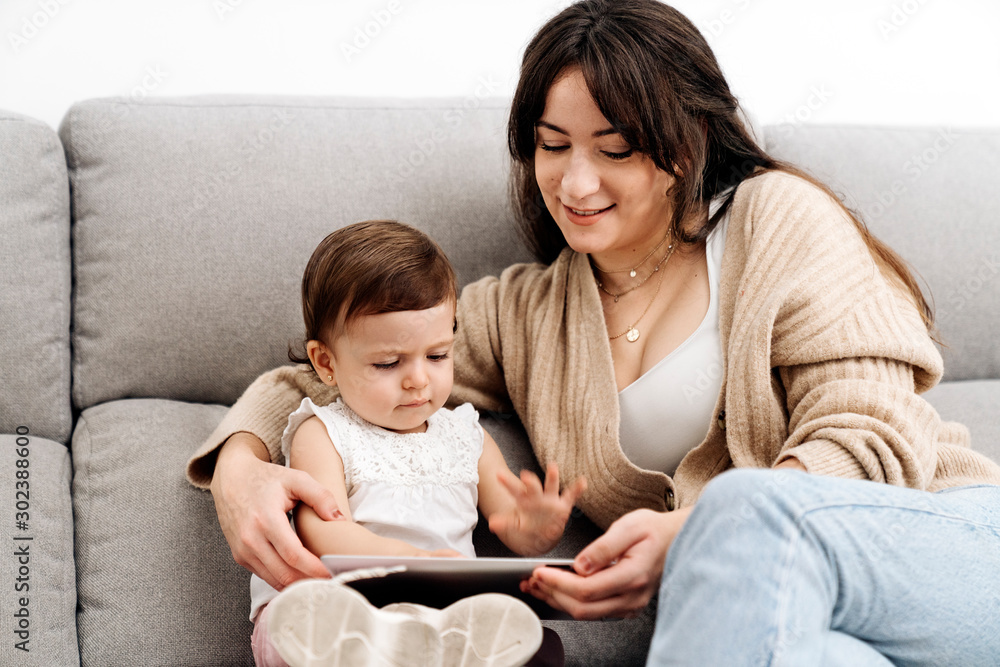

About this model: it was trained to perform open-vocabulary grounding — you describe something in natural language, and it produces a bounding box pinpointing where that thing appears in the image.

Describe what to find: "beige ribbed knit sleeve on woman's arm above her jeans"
[727,174,946,488]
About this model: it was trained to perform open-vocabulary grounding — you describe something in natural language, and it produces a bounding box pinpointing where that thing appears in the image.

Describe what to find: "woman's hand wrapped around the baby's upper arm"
[211,433,344,590]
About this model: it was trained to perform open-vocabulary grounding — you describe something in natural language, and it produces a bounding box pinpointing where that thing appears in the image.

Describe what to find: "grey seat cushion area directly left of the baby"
[72,400,253,667]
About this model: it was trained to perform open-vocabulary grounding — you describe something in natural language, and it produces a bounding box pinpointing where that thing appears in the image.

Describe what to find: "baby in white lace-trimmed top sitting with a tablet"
[251,221,586,665]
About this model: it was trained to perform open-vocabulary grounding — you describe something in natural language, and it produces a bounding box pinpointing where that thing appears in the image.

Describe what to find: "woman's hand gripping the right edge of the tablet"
[521,507,692,619]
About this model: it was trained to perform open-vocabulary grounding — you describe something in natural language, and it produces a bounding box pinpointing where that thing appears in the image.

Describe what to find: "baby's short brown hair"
[288,220,458,364]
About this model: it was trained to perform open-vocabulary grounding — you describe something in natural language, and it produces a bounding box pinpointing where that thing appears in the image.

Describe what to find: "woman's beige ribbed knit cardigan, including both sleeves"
[187,172,1000,527]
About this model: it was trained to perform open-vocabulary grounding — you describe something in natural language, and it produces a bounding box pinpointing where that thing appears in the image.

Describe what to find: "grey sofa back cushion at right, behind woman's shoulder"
[766,125,1000,380]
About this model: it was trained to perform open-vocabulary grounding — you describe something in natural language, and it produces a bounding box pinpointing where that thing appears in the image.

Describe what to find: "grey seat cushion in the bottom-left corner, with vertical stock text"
[0,428,79,667]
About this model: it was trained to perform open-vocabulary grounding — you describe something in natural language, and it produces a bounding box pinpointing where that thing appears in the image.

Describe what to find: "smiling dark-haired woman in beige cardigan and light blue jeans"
[189,0,1000,664]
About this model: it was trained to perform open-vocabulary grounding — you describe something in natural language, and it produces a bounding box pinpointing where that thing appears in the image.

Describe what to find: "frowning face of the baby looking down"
[333,300,455,433]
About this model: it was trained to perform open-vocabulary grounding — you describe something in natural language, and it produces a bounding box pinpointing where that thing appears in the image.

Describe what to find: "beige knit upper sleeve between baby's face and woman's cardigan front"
[448,276,513,412]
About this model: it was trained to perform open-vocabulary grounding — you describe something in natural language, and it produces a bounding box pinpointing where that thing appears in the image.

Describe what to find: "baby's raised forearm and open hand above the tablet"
[476,432,587,556]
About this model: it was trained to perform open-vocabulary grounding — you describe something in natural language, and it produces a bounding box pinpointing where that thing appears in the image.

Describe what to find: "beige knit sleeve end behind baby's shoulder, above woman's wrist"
[187,366,337,488]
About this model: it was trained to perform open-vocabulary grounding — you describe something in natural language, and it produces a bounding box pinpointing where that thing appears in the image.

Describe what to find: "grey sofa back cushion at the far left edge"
[0,111,72,443]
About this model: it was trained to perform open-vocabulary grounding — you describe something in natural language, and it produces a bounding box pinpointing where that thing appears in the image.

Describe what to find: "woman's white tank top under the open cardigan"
[618,206,729,475]
